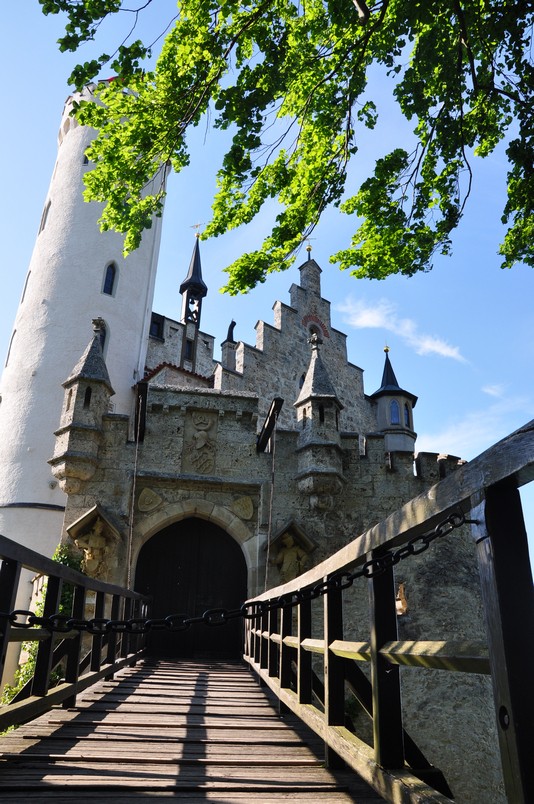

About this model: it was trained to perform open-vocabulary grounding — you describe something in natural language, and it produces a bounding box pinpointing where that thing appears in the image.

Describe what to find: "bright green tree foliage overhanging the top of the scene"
[39,0,534,293]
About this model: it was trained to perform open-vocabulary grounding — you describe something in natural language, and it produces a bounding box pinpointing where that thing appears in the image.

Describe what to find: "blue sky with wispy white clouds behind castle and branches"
[0,0,534,564]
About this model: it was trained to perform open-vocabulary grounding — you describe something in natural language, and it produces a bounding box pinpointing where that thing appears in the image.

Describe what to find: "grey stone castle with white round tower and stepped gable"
[0,89,504,801]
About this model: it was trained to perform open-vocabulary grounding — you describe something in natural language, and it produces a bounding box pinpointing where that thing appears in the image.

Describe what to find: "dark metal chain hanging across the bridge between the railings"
[0,511,477,635]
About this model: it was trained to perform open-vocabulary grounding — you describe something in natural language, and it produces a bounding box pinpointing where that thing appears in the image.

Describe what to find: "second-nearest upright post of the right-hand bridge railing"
[369,553,404,769]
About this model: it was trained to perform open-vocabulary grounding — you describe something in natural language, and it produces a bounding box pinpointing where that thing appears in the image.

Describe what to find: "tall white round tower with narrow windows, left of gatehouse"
[0,88,165,555]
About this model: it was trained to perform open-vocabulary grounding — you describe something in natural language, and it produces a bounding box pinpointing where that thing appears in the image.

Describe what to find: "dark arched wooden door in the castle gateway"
[135,518,247,658]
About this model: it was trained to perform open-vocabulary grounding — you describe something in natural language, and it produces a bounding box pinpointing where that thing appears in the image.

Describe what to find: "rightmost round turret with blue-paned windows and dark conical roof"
[371,346,417,452]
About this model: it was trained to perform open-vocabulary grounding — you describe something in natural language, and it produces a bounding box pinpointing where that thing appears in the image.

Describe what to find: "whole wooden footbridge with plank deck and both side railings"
[0,422,534,804]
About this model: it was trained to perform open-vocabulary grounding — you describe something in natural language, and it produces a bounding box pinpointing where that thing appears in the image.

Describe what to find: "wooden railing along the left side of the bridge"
[0,536,149,731]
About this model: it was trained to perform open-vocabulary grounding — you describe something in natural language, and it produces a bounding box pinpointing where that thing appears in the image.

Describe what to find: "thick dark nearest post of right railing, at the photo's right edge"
[473,480,534,804]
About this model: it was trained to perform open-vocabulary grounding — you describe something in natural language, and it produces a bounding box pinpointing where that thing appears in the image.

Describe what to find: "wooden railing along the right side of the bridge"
[245,421,534,804]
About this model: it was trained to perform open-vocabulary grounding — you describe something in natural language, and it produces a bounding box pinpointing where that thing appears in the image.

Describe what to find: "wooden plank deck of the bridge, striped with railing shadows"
[0,661,382,804]
